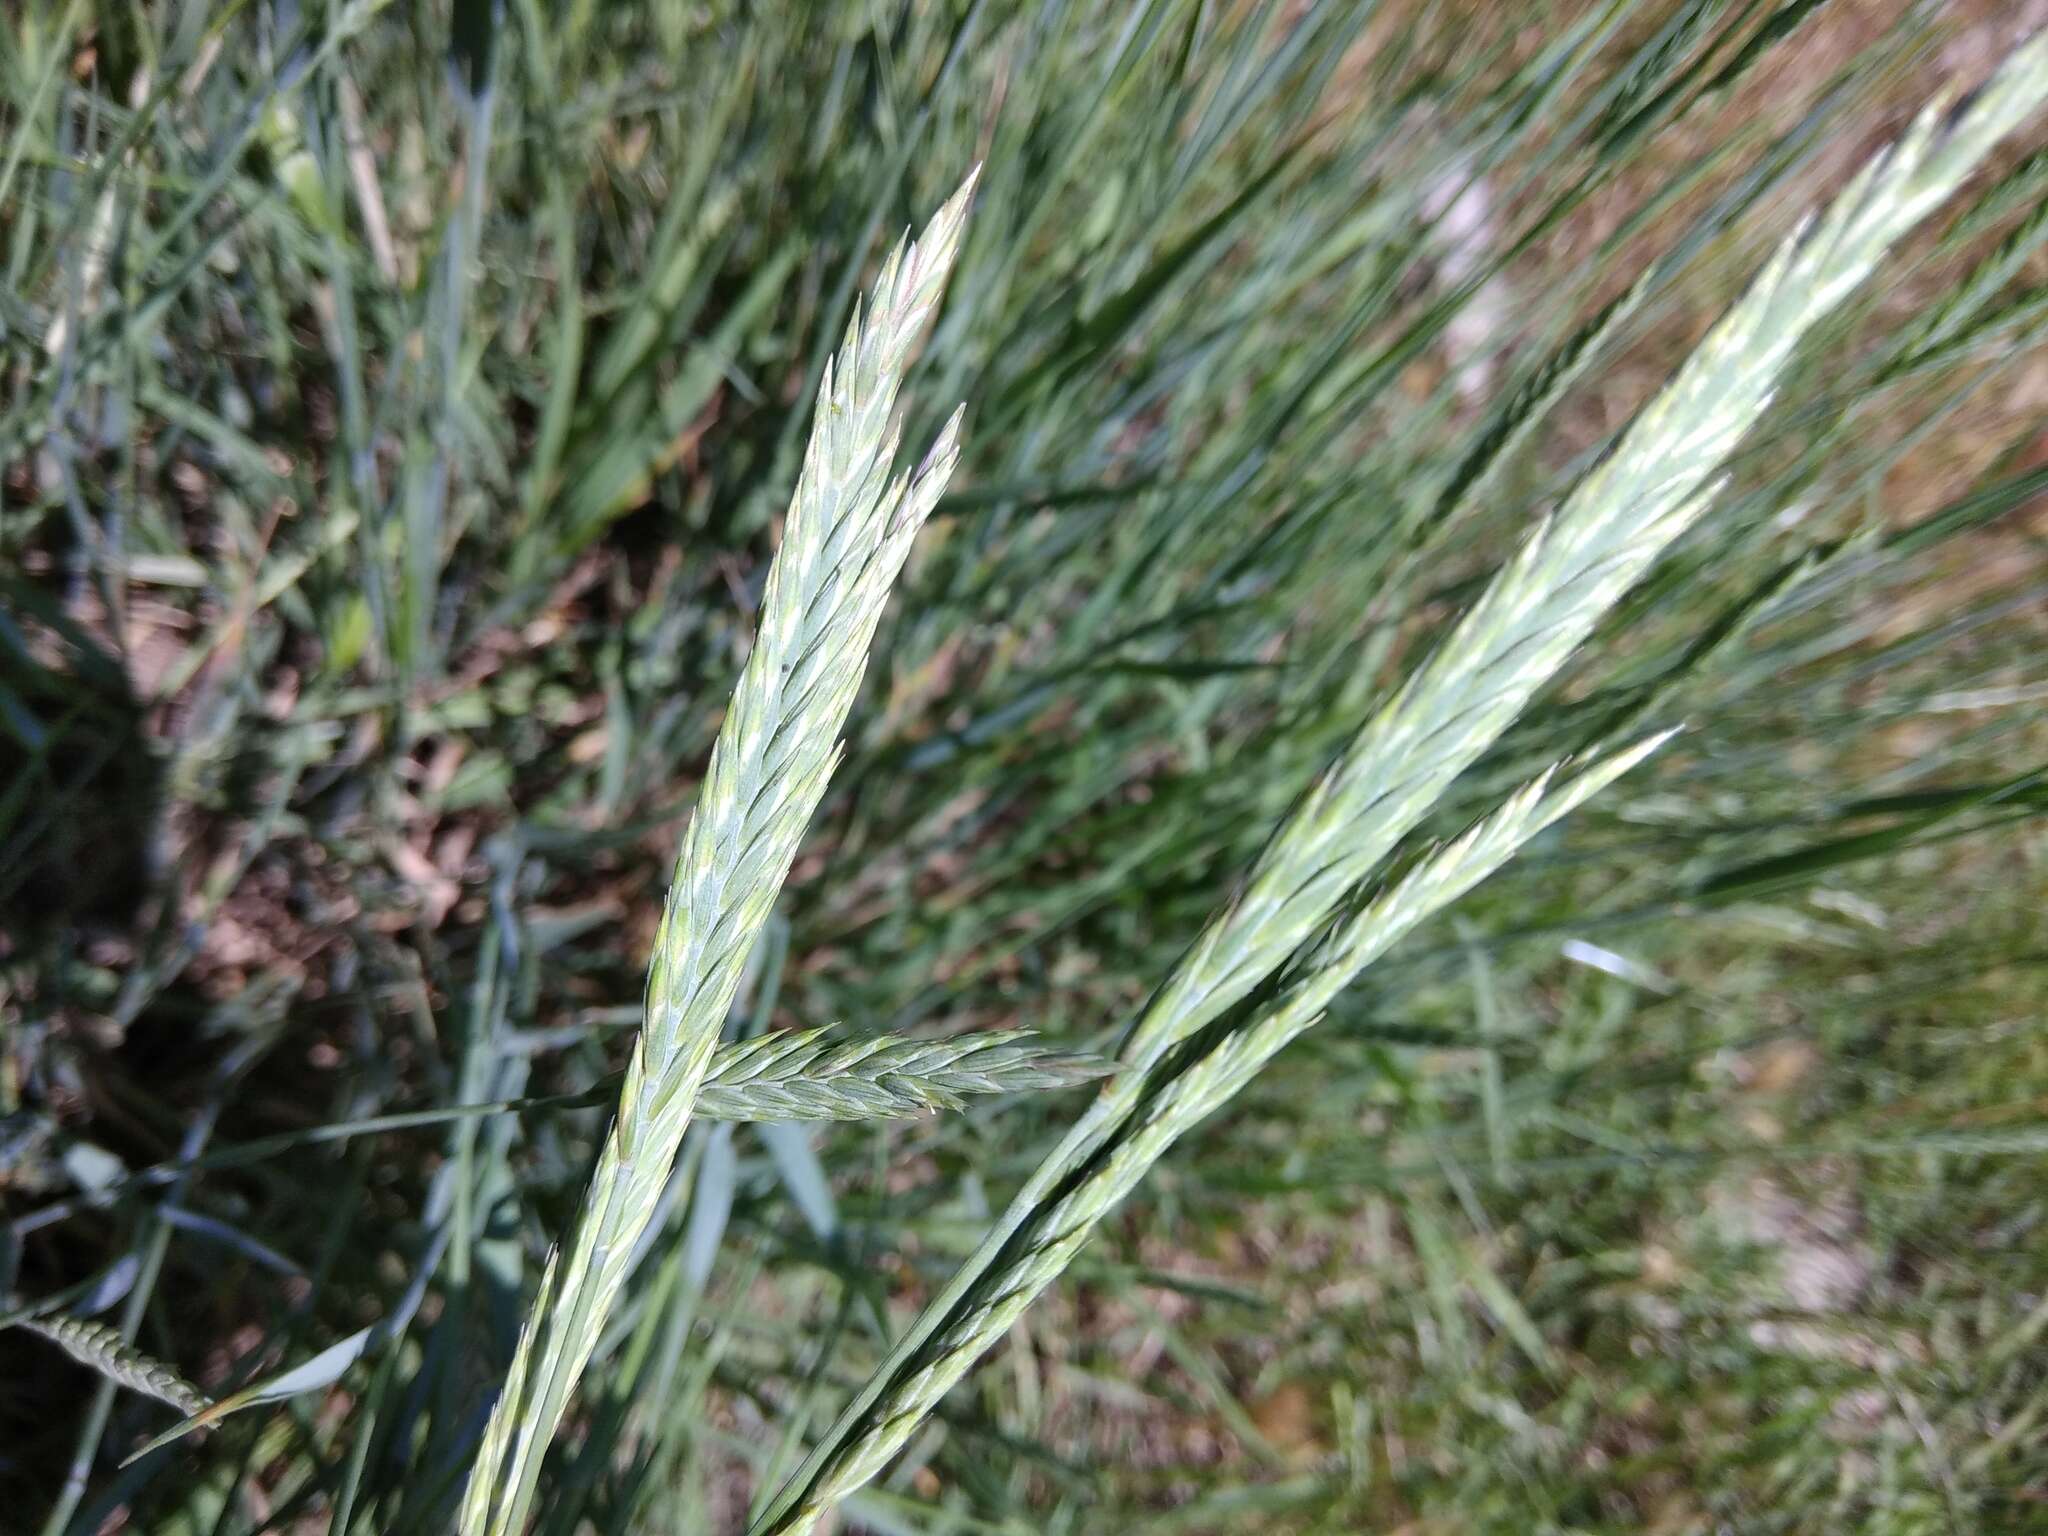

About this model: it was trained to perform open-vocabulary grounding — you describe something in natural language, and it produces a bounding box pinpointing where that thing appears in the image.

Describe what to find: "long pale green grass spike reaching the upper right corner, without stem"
[1130,27,2048,1081]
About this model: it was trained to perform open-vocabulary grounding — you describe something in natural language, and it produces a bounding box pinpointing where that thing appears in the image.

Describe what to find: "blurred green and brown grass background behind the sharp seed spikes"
[0,0,2048,1536]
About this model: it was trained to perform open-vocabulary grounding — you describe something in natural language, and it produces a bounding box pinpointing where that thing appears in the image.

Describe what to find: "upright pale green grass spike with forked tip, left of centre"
[461,176,973,1536]
